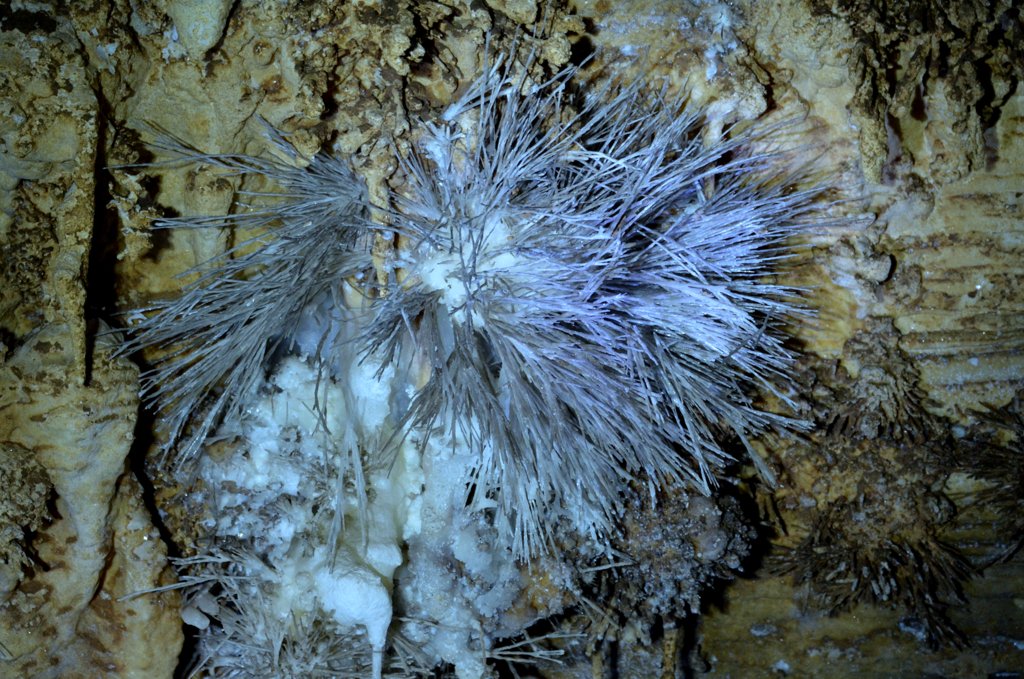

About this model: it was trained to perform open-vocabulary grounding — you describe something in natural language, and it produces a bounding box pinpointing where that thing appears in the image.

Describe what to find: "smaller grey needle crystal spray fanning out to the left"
[122,130,370,462]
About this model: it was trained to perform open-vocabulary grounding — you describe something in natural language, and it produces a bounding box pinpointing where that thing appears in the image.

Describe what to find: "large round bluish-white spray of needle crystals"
[365,58,810,555]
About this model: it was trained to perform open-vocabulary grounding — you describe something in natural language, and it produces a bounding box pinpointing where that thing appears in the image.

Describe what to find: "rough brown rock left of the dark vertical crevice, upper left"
[0,31,97,364]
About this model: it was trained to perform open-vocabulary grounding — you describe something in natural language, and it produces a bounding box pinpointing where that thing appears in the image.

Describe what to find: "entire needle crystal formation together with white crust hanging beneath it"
[123,50,816,676]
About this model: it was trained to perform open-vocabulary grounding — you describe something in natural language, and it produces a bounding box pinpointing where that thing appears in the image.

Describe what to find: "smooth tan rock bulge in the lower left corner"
[0,326,180,677]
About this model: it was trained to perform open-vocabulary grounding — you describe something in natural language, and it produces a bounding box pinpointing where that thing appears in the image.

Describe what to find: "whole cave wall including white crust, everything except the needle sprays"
[0,0,1024,677]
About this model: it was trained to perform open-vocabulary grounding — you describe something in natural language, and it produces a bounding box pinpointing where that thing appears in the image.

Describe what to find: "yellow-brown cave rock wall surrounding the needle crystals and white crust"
[0,0,1024,677]
